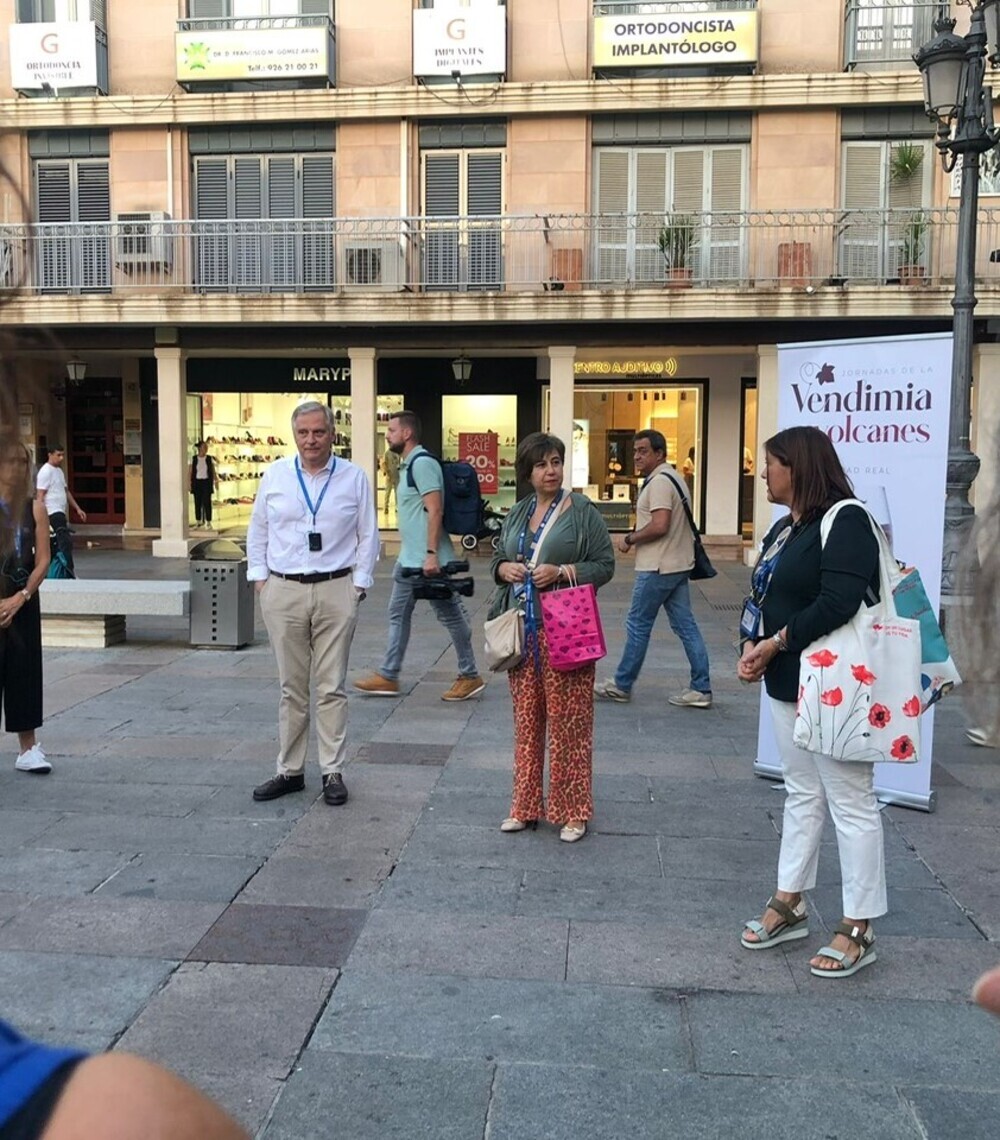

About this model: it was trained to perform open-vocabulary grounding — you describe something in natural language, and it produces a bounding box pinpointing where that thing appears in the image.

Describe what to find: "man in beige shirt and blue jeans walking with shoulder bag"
[594,430,712,709]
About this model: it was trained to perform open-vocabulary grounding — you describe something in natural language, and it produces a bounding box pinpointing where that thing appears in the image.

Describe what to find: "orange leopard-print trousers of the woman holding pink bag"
[507,630,594,823]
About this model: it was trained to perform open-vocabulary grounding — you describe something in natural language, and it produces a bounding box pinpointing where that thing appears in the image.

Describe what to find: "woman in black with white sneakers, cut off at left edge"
[0,434,52,775]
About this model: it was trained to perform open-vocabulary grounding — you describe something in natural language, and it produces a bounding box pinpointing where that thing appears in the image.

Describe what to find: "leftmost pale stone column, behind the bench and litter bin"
[153,348,189,559]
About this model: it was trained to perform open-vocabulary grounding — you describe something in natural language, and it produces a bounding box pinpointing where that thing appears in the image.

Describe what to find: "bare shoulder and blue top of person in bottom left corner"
[0,1020,247,1140]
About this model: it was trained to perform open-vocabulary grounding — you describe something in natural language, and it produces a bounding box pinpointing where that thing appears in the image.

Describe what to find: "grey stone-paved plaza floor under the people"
[0,547,1000,1140]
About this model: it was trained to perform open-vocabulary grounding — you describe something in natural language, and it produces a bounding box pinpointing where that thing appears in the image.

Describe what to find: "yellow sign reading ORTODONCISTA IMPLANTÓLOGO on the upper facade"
[594,9,758,67]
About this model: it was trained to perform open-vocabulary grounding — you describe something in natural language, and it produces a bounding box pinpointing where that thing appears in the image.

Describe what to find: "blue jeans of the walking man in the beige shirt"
[615,570,712,693]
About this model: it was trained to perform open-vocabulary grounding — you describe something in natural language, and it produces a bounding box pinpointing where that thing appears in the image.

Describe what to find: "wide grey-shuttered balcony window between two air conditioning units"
[194,154,335,292]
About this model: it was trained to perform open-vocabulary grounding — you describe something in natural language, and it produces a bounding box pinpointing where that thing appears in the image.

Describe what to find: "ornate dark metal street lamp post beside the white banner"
[913,0,1000,600]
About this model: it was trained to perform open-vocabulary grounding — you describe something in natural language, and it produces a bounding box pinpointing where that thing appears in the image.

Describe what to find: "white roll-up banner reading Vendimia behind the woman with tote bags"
[754,333,952,812]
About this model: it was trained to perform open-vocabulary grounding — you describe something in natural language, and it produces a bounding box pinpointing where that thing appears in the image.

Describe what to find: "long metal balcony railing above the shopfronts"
[0,207,1000,294]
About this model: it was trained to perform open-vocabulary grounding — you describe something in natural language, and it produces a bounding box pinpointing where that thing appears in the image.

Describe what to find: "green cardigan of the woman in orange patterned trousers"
[488,491,615,618]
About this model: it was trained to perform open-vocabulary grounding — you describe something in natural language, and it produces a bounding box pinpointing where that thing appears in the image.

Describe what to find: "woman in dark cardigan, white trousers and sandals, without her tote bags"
[737,428,887,978]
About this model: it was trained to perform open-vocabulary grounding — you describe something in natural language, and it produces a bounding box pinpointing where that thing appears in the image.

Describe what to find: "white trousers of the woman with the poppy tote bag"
[770,699,888,919]
